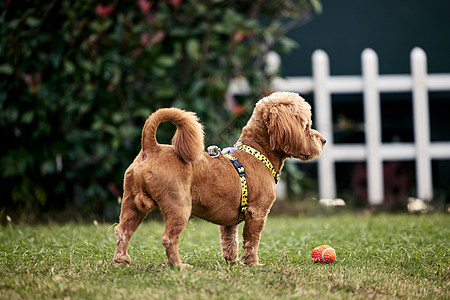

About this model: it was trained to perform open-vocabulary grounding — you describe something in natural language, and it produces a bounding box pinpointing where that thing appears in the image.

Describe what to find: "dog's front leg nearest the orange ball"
[241,208,267,266]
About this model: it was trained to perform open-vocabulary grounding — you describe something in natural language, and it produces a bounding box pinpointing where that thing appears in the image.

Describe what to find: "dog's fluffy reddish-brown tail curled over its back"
[141,108,205,162]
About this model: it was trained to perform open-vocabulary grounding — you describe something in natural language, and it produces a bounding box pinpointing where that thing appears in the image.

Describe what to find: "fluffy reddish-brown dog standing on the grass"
[113,92,325,267]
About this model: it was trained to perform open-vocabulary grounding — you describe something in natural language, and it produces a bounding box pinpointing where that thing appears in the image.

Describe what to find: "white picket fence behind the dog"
[230,48,450,205]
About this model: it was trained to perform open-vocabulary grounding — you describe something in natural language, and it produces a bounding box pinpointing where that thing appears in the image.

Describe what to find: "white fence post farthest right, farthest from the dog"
[410,47,433,200]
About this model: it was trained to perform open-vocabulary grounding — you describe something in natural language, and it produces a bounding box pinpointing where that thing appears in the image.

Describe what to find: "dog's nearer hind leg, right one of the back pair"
[160,196,192,268]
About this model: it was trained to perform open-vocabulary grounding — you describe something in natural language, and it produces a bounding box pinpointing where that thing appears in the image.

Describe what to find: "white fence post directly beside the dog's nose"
[312,50,336,198]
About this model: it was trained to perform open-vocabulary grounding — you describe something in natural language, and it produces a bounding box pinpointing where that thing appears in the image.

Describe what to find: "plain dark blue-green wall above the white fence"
[282,0,450,76]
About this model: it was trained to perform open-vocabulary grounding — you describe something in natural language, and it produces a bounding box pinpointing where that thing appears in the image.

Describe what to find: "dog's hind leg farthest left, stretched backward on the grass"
[113,191,157,264]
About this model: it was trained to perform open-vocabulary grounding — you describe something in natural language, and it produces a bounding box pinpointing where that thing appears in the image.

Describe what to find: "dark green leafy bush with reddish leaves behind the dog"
[0,0,317,223]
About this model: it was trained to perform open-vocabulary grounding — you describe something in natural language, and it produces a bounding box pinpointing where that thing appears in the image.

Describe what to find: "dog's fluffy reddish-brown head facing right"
[252,92,326,161]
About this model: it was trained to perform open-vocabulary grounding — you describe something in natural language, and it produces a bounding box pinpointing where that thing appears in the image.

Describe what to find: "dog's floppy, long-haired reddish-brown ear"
[266,104,308,155]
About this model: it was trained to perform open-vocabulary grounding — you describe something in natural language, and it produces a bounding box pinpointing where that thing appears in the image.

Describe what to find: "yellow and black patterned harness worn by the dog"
[207,142,280,224]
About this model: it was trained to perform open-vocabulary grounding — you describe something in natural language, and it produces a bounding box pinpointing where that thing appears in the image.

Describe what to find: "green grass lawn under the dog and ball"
[0,214,450,299]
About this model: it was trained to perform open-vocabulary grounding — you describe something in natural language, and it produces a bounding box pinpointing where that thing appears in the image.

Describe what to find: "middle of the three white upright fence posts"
[361,49,384,205]
